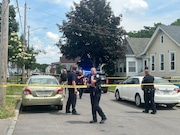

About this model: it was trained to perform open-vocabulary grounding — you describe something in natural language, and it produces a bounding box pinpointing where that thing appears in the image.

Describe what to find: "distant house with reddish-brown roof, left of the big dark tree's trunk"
[60,56,80,70]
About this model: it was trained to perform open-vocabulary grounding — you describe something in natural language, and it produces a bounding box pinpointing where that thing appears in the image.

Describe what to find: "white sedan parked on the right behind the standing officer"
[115,76,180,107]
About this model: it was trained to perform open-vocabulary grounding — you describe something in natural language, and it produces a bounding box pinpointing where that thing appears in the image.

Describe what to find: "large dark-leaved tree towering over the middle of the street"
[56,0,125,68]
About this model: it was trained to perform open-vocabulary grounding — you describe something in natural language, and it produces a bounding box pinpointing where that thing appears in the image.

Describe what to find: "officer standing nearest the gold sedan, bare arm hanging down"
[66,65,79,115]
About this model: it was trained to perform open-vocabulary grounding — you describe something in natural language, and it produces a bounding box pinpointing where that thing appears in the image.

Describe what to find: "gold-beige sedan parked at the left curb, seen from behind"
[22,75,64,110]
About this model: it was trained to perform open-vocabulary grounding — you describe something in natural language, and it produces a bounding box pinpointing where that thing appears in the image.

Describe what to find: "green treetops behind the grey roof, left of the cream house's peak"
[128,23,161,38]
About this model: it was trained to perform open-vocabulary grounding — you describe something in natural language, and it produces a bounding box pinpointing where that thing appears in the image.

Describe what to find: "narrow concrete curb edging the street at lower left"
[7,99,22,135]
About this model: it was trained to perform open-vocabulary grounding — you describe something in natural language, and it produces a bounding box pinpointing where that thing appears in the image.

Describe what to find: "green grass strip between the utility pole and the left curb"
[0,86,23,119]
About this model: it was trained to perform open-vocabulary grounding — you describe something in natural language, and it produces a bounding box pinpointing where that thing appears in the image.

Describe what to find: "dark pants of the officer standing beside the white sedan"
[144,90,156,112]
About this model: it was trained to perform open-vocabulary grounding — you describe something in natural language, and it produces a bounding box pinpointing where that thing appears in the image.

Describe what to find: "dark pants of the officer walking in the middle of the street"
[90,92,106,121]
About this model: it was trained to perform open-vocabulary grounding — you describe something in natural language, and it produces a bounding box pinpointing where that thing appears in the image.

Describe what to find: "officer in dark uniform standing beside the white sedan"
[142,67,157,114]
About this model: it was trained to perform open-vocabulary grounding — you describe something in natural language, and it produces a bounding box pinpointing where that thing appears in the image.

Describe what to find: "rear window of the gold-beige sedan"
[29,78,57,85]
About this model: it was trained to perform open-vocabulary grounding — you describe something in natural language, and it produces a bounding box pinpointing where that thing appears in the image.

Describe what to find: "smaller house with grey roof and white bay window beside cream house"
[115,37,150,76]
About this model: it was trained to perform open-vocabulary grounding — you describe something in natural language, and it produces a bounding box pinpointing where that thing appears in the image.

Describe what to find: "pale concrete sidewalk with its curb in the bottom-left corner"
[0,100,21,135]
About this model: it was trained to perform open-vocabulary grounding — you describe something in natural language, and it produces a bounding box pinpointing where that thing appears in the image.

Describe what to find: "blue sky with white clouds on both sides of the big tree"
[7,0,180,64]
